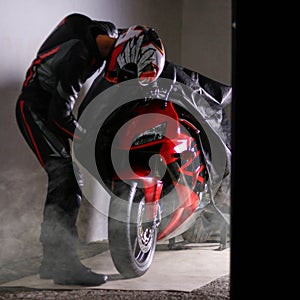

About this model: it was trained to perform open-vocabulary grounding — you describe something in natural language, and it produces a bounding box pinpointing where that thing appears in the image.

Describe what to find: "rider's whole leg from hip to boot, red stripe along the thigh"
[16,99,107,285]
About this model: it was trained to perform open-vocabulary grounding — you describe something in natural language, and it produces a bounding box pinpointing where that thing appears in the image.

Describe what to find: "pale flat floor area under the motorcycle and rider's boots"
[0,243,230,292]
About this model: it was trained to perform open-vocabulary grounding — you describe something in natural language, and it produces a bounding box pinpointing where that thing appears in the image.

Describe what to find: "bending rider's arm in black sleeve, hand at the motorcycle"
[48,42,89,139]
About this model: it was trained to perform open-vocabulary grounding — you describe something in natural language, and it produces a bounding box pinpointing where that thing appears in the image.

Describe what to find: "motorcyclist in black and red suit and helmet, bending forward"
[16,14,165,286]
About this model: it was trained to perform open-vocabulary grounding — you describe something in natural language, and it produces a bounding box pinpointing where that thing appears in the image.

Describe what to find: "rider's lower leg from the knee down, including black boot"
[40,158,106,285]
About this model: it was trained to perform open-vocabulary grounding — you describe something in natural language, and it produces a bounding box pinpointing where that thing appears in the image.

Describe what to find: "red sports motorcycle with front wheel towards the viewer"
[74,64,230,278]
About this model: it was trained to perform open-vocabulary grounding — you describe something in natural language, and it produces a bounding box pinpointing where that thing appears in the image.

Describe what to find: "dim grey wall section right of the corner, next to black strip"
[181,0,232,85]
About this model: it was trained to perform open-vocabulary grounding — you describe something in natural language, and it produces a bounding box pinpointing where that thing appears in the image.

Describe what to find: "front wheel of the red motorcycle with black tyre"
[108,182,157,278]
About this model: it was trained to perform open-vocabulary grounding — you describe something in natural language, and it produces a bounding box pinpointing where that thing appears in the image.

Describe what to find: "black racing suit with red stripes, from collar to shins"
[16,14,118,251]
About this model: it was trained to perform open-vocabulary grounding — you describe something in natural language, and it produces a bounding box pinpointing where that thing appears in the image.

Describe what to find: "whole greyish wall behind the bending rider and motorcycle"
[0,0,230,264]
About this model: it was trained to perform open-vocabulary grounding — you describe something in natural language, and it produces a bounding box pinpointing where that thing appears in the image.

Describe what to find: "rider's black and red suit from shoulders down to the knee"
[17,14,117,166]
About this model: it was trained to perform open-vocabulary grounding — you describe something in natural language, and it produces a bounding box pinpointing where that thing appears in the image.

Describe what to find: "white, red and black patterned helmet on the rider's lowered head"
[105,25,165,85]
